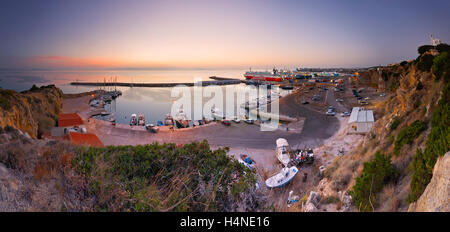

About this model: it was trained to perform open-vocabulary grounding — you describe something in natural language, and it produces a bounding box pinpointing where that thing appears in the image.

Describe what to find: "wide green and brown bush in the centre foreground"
[73,141,257,211]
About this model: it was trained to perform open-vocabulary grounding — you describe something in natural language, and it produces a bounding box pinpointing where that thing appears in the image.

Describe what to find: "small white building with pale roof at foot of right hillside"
[348,107,375,134]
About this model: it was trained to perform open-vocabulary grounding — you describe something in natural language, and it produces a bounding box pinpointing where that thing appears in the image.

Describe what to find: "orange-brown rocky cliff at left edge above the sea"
[0,85,63,138]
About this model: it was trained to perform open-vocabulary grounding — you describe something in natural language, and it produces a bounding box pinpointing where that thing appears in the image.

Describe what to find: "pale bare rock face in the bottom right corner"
[408,152,450,212]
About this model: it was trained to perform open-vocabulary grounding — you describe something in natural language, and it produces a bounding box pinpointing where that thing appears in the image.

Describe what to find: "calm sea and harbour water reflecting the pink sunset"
[0,69,288,124]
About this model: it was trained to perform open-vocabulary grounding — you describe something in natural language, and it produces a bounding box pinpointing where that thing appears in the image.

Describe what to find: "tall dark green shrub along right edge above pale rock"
[408,82,450,202]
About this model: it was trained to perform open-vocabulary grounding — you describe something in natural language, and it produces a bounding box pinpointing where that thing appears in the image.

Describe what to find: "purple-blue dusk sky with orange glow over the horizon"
[0,0,450,70]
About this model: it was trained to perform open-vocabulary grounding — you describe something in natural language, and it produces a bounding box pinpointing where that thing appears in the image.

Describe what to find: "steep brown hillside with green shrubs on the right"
[300,45,450,211]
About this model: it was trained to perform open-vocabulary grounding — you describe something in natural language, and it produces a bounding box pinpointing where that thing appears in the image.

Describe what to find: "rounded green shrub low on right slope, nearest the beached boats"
[350,151,399,211]
